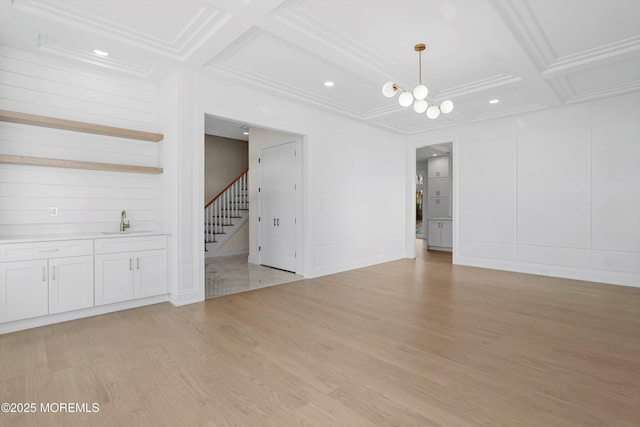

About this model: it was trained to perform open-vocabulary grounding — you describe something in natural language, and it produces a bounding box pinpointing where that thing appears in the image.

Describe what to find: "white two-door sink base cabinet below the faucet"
[95,236,167,306]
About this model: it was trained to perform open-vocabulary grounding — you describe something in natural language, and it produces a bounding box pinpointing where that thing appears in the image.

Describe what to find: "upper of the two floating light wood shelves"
[0,110,164,142]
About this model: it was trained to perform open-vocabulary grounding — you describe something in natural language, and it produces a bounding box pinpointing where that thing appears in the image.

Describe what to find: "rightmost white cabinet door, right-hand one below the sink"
[133,249,167,298]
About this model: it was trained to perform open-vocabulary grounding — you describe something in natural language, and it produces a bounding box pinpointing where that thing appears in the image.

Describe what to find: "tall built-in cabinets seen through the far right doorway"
[427,156,453,250]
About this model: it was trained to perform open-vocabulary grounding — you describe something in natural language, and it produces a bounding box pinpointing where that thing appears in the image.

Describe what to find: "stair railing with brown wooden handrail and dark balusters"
[204,168,249,243]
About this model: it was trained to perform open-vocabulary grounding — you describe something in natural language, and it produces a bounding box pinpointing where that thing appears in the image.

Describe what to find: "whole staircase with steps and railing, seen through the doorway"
[204,168,249,257]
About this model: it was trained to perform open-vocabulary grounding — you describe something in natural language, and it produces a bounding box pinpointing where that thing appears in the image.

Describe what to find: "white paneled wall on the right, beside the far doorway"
[409,94,640,286]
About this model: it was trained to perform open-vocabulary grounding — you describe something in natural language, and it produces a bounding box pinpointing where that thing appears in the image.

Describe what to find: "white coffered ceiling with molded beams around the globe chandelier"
[0,0,640,134]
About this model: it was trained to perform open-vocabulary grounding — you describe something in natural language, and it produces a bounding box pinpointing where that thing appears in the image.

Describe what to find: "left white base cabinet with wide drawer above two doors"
[0,240,93,322]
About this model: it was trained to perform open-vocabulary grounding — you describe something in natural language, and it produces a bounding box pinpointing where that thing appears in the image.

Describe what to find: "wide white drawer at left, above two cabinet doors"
[0,240,93,262]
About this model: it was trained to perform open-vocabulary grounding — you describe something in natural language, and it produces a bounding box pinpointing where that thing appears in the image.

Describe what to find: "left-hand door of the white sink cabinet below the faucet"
[95,252,133,306]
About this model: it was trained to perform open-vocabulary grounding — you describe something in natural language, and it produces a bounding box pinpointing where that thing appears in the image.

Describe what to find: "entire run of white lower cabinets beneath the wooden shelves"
[0,233,167,333]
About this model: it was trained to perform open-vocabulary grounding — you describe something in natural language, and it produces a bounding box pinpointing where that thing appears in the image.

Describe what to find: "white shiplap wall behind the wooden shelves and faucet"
[0,48,161,236]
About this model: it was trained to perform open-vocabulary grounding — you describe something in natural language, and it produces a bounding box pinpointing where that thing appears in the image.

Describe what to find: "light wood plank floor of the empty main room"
[0,251,640,427]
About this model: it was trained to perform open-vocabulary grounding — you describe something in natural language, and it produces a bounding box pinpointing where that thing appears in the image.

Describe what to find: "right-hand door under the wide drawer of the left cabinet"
[49,255,93,314]
